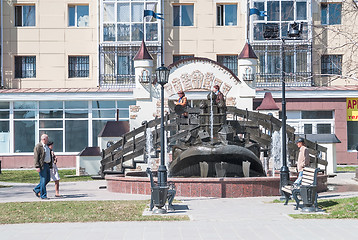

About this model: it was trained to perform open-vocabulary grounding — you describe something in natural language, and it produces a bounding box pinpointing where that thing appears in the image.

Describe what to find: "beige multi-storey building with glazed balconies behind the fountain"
[0,0,358,167]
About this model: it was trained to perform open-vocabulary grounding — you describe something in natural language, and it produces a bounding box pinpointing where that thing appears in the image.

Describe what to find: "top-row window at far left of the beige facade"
[15,5,36,27]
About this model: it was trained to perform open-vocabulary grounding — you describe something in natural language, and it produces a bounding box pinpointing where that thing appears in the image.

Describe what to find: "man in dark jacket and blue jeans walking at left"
[33,134,52,199]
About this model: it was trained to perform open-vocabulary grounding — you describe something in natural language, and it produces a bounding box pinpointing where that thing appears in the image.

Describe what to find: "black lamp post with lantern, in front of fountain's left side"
[155,64,170,187]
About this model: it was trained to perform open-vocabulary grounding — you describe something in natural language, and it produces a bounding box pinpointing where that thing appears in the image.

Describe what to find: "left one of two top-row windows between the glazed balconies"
[173,5,194,26]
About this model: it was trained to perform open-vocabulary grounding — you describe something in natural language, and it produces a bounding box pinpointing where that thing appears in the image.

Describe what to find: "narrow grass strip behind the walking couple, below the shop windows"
[0,169,93,183]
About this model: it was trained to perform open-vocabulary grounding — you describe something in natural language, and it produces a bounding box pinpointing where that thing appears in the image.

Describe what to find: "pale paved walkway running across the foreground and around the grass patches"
[0,173,358,240]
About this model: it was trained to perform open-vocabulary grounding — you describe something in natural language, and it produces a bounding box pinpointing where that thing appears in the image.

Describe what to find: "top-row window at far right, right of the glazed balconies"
[321,3,342,25]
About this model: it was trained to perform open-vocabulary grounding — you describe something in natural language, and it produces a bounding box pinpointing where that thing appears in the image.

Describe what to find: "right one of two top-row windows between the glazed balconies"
[216,4,237,26]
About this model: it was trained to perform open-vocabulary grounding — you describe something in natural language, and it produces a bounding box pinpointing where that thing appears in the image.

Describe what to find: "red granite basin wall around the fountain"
[106,175,327,198]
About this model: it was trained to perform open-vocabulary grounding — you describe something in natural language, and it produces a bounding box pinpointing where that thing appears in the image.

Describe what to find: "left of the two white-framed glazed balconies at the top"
[103,0,159,42]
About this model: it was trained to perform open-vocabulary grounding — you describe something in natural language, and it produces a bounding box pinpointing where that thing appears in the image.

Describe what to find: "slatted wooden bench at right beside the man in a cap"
[281,167,320,210]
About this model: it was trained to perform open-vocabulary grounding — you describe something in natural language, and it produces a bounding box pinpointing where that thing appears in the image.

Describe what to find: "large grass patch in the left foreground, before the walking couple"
[0,200,189,224]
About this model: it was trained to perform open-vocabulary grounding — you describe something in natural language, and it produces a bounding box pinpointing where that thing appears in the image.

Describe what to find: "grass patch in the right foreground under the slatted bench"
[290,197,358,219]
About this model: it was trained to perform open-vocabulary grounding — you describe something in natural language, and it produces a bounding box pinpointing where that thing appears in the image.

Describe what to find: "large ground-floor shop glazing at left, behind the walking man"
[0,100,136,153]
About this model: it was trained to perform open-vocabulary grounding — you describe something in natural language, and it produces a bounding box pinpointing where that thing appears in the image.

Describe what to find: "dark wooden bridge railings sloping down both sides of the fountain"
[101,107,327,174]
